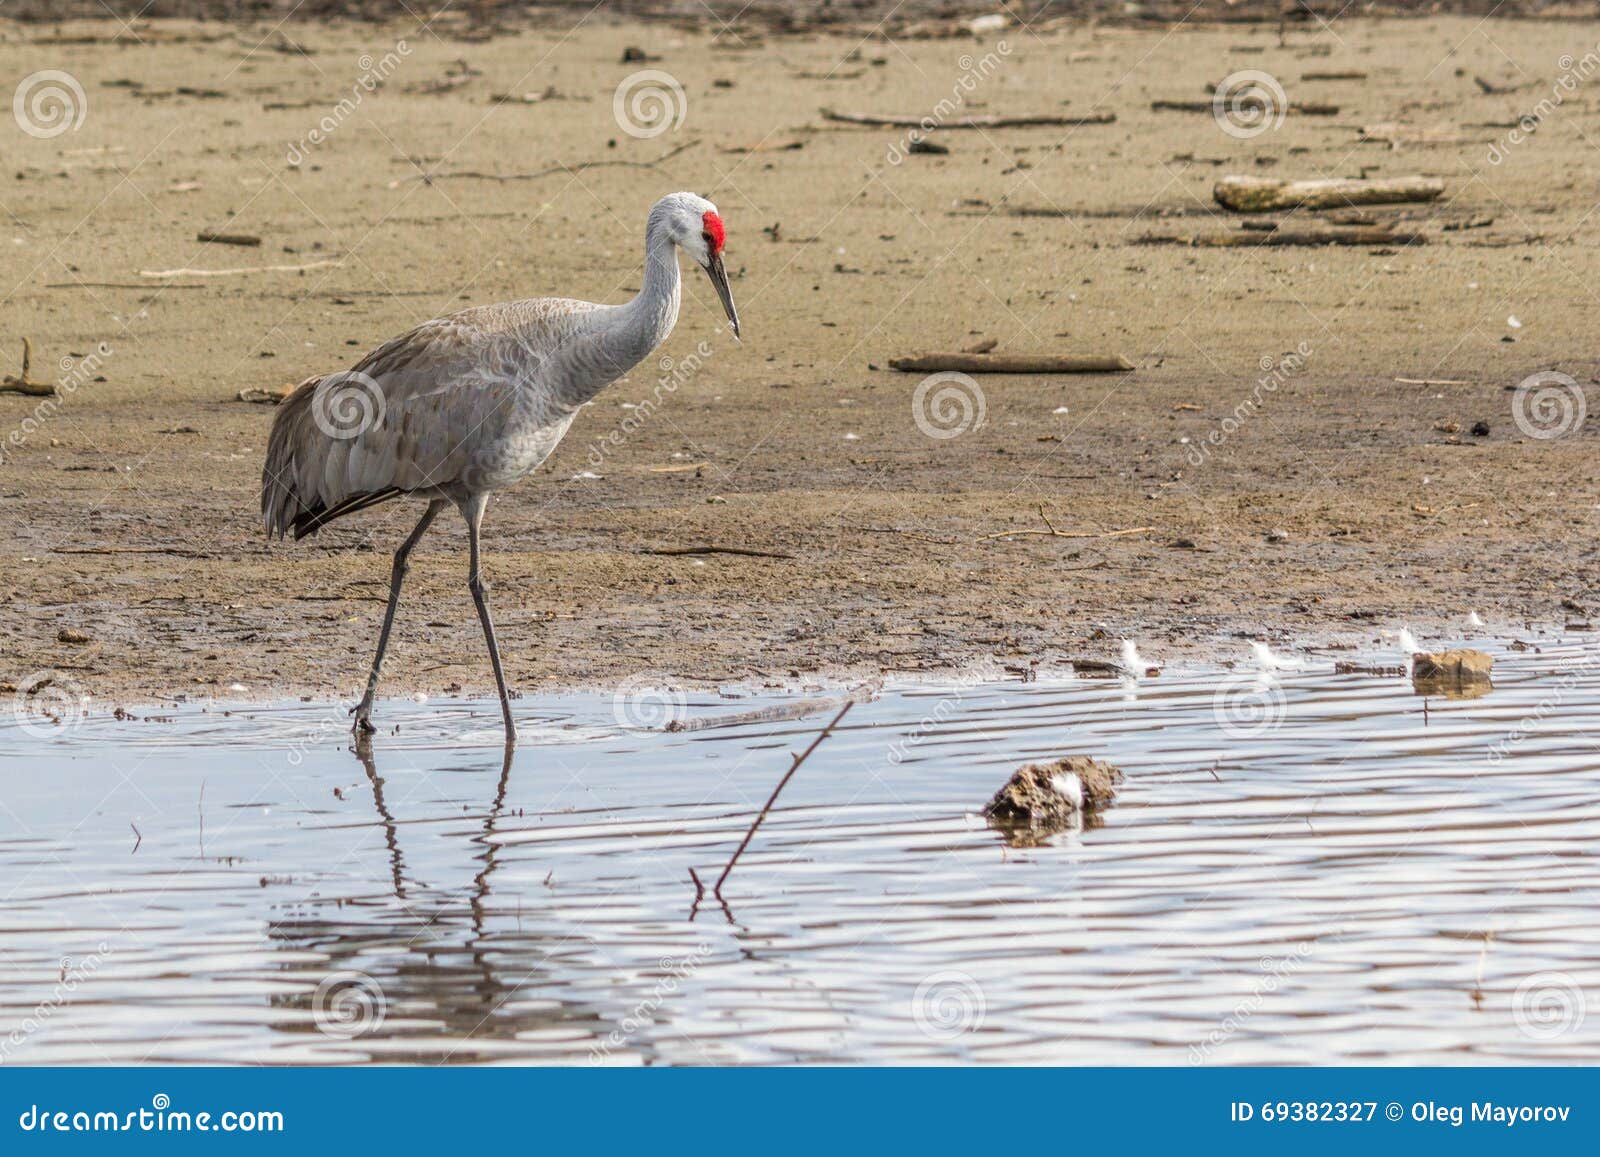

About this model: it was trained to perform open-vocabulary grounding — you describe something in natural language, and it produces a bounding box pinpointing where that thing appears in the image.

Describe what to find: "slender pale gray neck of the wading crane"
[562,214,682,406]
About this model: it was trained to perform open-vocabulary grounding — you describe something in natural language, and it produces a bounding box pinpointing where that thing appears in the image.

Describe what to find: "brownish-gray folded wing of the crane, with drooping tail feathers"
[261,302,581,538]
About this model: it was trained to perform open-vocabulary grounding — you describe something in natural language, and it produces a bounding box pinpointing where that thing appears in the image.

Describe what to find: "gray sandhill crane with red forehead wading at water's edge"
[261,192,739,739]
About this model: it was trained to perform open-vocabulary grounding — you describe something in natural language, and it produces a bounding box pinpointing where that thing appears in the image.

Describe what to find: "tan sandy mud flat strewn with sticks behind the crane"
[0,18,1600,703]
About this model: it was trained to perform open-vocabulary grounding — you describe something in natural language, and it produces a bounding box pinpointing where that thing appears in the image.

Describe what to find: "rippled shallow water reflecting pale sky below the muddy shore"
[0,639,1600,1064]
